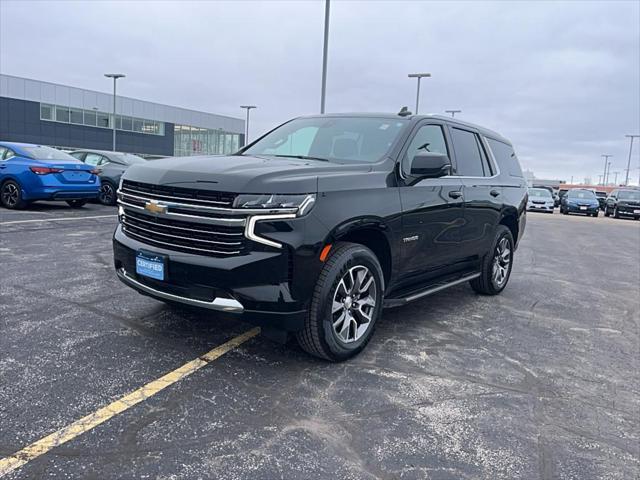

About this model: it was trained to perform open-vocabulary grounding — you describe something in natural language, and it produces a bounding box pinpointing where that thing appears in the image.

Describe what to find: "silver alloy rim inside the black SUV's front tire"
[331,265,377,343]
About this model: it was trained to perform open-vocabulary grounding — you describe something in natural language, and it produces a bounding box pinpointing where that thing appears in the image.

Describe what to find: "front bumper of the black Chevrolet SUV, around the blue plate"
[113,226,320,331]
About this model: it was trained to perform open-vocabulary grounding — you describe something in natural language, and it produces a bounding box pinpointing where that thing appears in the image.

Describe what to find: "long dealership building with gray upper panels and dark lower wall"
[0,74,245,157]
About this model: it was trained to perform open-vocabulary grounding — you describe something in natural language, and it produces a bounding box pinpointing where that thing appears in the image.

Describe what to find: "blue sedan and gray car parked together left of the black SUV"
[0,142,145,209]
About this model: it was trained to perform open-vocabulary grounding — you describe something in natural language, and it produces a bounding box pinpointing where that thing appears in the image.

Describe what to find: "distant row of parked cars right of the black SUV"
[527,187,640,220]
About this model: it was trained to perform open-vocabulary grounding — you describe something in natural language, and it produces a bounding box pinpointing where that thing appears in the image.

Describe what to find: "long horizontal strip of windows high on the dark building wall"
[40,103,164,135]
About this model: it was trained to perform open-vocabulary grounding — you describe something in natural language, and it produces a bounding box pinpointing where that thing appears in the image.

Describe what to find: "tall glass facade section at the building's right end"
[173,125,240,157]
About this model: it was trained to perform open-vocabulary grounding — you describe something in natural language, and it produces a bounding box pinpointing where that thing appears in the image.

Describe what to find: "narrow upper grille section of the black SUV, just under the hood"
[121,180,237,208]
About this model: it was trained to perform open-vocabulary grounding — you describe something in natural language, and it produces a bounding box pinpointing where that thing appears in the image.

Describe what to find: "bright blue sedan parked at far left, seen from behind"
[0,142,100,209]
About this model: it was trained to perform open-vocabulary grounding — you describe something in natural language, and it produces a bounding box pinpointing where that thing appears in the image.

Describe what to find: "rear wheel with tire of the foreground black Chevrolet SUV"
[469,225,514,295]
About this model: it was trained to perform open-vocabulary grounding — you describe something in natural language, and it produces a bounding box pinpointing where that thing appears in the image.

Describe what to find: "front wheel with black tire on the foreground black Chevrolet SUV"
[296,242,384,362]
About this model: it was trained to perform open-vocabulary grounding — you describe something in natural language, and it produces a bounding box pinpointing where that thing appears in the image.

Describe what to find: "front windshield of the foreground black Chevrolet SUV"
[242,117,407,163]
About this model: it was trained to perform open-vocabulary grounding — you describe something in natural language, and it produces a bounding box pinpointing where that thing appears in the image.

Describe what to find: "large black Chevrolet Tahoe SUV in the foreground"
[113,114,527,360]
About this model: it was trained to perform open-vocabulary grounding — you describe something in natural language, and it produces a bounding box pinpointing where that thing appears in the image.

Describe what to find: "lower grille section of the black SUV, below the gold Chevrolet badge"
[121,208,248,257]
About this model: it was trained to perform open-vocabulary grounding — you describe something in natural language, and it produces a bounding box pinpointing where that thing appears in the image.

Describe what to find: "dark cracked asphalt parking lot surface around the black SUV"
[0,203,640,479]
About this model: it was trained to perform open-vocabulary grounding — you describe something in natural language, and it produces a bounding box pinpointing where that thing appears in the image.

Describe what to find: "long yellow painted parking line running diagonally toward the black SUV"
[0,327,260,478]
